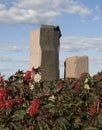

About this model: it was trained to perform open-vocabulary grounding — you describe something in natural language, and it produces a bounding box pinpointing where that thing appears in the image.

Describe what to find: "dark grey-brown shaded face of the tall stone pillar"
[40,25,61,80]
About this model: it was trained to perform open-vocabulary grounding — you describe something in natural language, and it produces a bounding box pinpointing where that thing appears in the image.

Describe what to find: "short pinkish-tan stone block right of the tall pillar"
[65,56,89,78]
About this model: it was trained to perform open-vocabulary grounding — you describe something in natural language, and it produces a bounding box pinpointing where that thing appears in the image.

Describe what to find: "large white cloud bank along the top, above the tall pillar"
[0,0,91,25]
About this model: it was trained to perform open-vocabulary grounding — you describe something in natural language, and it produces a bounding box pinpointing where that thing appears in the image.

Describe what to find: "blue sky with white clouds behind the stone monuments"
[0,0,102,77]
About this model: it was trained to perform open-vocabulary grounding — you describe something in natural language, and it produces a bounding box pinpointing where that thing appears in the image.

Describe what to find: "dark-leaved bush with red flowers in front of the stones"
[0,68,102,130]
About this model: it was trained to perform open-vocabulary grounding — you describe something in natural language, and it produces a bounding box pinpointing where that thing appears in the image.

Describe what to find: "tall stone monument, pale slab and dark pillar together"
[30,25,61,80]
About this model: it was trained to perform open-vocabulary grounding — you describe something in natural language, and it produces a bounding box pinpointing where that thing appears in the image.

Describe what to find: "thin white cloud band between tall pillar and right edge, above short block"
[61,37,102,52]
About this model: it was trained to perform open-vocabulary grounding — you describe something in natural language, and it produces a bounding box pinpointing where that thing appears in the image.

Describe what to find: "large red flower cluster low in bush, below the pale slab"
[29,99,41,116]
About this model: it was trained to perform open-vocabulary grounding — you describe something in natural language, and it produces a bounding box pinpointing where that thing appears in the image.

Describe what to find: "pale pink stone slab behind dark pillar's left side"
[30,30,41,70]
